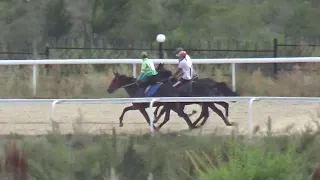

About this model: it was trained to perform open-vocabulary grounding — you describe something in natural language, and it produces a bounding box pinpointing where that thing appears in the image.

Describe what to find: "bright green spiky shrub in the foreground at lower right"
[188,141,301,180]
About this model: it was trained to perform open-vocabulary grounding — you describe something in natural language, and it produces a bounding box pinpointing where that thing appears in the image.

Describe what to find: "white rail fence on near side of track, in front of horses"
[0,96,320,139]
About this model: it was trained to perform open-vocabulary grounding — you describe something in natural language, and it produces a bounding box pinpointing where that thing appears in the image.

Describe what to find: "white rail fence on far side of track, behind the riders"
[0,57,320,96]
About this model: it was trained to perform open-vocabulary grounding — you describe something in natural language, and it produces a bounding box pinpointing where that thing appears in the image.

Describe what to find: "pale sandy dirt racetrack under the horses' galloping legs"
[0,102,320,135]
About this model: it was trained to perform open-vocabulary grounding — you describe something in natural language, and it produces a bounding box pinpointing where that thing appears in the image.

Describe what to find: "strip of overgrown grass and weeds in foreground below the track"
[0,117,320,180]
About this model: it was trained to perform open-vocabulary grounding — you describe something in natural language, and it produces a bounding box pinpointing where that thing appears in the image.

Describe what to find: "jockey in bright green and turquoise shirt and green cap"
[136,52,158,97]
